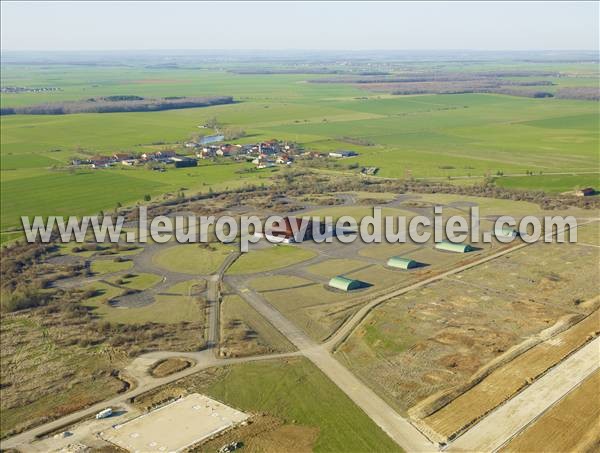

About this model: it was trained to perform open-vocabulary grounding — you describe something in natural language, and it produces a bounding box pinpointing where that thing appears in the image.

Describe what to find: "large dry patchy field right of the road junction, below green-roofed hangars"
[337,240,600,413]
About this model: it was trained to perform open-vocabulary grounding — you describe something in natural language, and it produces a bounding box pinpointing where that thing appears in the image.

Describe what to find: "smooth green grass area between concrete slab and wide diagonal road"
[208,359,401,452]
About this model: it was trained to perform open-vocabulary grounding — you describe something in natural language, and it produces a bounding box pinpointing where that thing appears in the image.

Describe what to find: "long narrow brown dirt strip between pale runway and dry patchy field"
[418,311,600,441]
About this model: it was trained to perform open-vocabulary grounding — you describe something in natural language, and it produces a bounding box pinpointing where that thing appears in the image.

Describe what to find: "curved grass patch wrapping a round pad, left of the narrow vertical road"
[83,282,204,324]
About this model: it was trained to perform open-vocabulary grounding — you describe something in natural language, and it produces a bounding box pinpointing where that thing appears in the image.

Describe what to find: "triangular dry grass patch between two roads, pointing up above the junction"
[220,295,294,357]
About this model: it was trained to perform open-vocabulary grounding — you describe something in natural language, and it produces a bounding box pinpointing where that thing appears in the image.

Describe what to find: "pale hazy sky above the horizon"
[0,0,600,51]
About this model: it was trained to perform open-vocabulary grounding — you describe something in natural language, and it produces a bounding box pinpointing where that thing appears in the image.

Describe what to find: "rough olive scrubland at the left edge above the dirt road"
[0,313,123,437]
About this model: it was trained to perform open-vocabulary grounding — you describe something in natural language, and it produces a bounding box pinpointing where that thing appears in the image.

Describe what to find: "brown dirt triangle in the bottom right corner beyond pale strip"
[500,371,600,453]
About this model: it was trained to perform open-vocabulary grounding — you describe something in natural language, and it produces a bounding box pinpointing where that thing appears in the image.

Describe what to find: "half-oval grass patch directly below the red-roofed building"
[227,245,316,274]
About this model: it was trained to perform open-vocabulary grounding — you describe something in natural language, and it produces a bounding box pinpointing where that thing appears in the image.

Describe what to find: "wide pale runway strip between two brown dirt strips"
[447,338,600,452]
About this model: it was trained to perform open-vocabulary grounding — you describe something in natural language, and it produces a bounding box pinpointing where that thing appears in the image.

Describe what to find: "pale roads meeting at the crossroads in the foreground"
[1,219,598,451]
